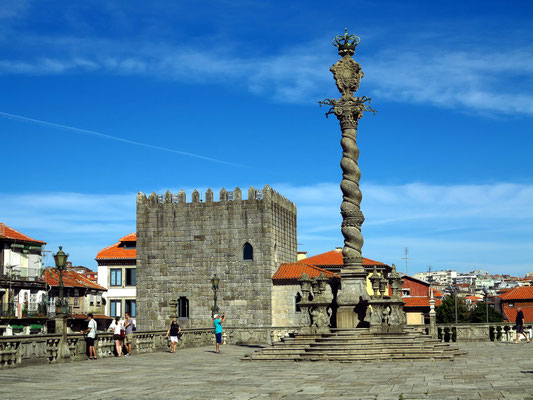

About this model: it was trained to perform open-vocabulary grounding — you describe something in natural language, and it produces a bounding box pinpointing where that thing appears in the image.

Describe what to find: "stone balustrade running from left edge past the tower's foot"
[0,327,297,368]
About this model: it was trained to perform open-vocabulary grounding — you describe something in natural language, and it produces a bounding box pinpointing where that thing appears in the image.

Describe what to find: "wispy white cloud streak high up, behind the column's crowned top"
[0,32,533,115]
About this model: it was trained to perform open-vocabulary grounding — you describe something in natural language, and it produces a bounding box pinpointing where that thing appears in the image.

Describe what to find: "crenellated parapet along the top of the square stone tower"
[137,185,296,212]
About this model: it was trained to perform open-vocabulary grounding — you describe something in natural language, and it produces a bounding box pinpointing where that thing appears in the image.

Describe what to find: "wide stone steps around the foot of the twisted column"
[242,329,465,362]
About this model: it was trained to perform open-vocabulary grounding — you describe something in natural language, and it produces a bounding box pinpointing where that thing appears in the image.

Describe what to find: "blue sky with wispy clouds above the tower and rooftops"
[0,0,533,275]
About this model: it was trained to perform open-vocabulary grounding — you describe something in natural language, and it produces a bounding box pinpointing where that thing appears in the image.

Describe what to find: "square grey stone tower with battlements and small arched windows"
[137,186,297,330]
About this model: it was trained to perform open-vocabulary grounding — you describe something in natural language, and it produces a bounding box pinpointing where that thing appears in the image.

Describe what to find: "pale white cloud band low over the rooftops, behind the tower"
[0,183,533,274]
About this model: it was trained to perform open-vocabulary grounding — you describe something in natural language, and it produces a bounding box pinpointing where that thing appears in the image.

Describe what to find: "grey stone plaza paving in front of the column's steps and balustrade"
[0,342,533,400]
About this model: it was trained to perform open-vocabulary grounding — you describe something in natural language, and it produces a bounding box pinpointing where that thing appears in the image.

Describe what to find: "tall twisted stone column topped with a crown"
[320,30,374,328]
